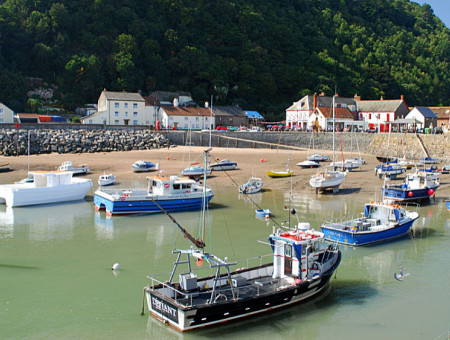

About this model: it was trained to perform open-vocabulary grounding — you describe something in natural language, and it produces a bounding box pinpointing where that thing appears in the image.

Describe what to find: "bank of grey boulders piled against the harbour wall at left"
[0,129,169,156]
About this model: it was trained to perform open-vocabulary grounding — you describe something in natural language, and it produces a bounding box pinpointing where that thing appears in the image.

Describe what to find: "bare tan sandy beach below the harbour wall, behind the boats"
[0,146,450,200]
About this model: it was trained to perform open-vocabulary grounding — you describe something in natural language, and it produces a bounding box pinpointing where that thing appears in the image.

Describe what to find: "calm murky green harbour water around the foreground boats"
[0,182,450,339]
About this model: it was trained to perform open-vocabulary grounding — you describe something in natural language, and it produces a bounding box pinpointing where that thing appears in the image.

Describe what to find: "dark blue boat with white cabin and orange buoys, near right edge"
[383,171,440,202]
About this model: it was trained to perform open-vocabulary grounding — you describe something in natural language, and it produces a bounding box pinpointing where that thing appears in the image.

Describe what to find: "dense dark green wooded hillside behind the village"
[0,0,450,118]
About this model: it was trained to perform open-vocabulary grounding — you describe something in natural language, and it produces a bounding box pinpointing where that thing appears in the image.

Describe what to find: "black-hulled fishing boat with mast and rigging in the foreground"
[142,149,341,332]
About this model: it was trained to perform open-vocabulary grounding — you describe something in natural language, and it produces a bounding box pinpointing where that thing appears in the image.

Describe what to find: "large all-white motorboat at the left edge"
[0,171,92,207]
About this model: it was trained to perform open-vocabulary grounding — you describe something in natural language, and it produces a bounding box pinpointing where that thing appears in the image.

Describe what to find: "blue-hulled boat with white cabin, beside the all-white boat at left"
[94,172,214,216]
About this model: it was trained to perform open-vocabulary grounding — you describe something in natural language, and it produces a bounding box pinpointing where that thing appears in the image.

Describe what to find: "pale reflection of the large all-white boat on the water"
[0,201,94,241]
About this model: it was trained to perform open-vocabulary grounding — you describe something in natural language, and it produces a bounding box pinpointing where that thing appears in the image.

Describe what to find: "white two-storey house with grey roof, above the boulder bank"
[81,89,146,125]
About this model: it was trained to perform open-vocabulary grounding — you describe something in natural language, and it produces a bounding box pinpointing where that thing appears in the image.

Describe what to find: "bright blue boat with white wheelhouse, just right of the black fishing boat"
[321,202,419,246]
